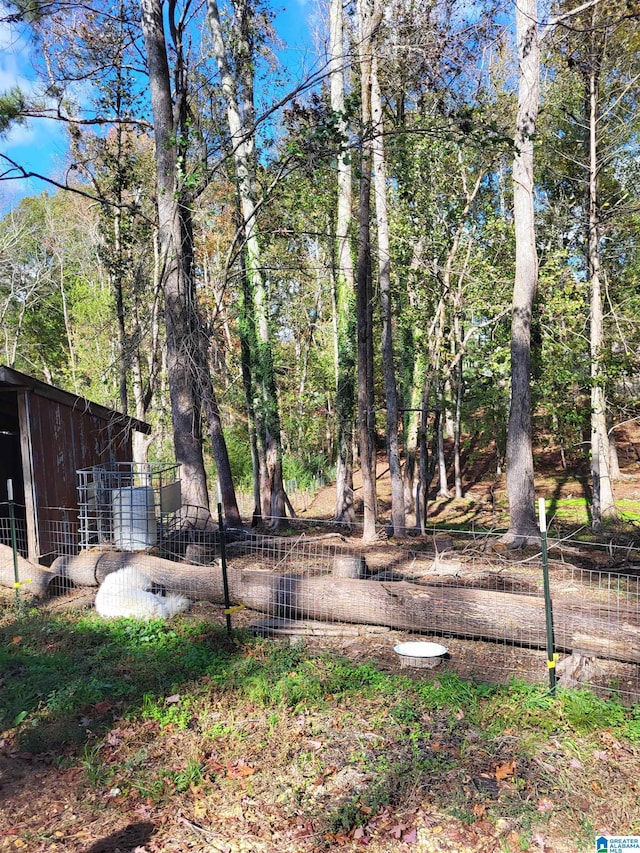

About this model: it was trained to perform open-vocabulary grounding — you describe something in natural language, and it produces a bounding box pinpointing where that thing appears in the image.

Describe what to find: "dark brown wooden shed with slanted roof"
[0,366,151,563]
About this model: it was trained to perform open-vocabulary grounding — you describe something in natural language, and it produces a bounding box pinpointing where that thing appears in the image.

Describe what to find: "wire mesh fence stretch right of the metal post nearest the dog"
[220,534,640,701]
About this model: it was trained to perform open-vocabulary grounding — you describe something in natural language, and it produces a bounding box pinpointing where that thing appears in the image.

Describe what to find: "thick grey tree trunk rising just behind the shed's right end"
[141,0,209,508]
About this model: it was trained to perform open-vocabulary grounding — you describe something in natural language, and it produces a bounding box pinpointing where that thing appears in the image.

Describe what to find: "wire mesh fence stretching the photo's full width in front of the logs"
[0,508,640,702]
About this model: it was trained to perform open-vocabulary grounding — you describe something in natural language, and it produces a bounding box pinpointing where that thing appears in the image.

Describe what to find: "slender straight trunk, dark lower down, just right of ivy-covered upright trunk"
[356,0,377,541]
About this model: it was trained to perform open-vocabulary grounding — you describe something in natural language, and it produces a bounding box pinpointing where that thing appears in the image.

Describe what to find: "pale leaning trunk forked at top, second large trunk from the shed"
[207,0,285,527]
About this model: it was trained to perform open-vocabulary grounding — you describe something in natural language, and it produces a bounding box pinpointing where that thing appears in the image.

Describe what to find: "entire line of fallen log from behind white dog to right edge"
[46,551,640,663]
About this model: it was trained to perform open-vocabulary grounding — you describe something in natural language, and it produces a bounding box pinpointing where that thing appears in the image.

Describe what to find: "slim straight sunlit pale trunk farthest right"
[586,55,616,530]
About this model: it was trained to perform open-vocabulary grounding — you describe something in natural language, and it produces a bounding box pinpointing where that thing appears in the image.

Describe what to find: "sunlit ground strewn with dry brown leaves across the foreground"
[0,588,640,853]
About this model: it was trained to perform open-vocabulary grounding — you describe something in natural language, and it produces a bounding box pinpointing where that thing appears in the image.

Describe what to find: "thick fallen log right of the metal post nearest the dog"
[233,571,640,663]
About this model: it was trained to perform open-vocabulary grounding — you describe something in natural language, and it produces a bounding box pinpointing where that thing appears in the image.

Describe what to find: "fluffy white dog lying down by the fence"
[96,566,189,619]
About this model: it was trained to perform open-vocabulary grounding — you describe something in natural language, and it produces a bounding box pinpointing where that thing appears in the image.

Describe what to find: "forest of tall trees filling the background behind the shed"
[0,0,640,543]
